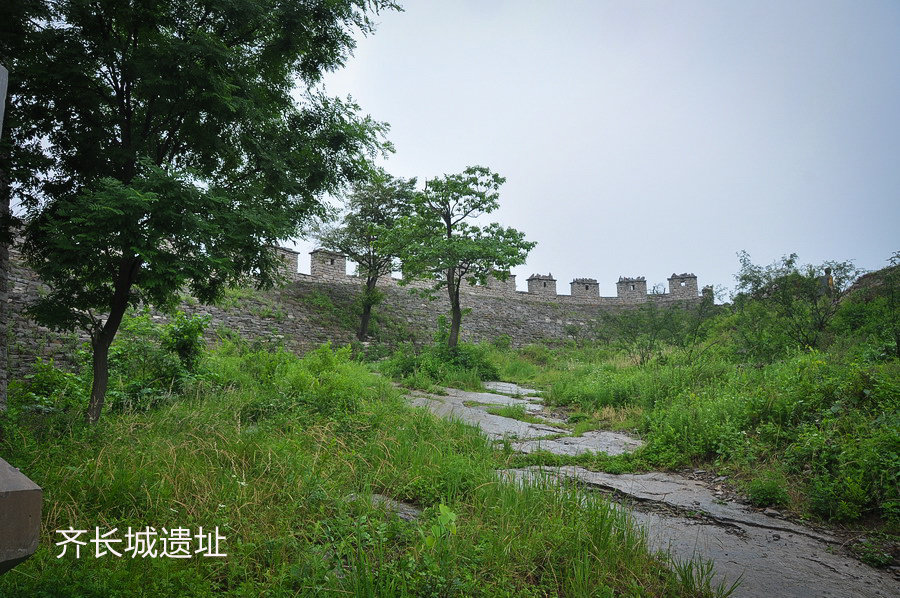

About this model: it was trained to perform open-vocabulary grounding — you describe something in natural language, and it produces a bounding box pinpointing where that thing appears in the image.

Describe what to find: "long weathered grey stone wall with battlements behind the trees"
[6,248,712,379]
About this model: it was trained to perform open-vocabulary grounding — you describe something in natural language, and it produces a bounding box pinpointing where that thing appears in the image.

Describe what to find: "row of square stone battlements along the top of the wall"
[277,248,712,307]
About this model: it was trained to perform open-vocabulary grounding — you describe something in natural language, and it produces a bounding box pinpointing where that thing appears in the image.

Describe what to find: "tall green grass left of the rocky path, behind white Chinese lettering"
[0,343,725,596]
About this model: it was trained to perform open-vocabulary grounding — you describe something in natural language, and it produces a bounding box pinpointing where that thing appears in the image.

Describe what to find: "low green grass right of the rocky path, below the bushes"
[489,344,900,529]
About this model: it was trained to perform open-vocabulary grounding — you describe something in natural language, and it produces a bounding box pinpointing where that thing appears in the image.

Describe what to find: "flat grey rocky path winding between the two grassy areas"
[410,382,900,598]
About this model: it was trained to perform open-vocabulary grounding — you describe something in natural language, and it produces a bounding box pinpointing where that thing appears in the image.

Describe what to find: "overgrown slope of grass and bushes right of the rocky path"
[478,253,900,529]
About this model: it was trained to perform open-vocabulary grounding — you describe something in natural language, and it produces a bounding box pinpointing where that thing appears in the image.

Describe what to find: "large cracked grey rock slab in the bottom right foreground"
[501,467,900,598]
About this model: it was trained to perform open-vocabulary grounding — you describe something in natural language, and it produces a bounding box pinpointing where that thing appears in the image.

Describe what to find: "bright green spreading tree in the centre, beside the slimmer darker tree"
[390,166,535,347]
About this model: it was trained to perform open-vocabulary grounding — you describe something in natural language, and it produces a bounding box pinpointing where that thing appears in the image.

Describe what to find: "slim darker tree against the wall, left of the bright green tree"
[315,170,416,341]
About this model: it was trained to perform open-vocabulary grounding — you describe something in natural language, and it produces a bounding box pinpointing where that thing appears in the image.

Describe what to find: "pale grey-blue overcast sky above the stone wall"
[290,0,900,295]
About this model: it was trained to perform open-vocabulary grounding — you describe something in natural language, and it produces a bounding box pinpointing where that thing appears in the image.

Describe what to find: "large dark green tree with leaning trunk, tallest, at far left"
[0,0,395,421]
